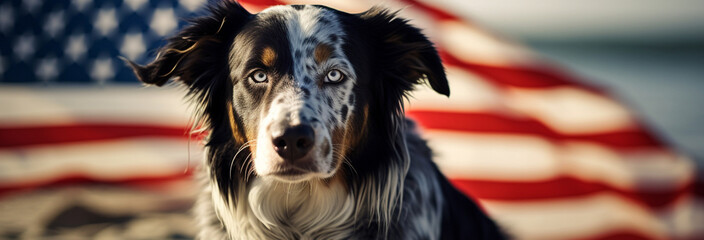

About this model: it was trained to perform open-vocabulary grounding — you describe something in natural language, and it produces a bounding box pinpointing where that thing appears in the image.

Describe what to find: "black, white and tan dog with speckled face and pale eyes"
[126,1,504,239]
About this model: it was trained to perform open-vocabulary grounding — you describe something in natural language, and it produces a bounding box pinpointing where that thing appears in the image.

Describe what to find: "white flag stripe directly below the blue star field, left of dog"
[0,85,190,127]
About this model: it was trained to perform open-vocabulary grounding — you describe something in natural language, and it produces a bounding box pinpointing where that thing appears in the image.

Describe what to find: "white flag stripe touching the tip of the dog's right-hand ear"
[407,67,636,134]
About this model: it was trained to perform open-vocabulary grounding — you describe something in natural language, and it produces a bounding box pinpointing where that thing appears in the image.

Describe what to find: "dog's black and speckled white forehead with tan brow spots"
[243,5,354,78]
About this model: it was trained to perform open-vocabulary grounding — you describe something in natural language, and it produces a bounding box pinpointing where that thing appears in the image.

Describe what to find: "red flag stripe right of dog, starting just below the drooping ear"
[406,110,665,150]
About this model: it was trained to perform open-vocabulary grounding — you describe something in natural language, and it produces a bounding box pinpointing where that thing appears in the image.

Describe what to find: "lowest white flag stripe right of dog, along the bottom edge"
[481,194,667,240]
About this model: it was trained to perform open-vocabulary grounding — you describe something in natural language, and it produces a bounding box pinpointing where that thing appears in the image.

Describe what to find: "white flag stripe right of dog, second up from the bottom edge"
[425,131,694,190]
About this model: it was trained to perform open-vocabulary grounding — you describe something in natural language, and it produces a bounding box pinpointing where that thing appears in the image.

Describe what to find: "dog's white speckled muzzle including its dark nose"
[254,88,337,182]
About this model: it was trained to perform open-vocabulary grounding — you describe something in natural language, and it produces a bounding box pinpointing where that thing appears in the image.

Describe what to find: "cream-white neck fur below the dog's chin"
[211,175,355,239]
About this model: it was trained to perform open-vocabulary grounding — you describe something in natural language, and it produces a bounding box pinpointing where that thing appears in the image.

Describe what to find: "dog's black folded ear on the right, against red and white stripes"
[360,7,450,96]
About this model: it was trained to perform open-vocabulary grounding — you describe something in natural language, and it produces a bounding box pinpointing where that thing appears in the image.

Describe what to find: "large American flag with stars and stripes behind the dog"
[0,0,704,239]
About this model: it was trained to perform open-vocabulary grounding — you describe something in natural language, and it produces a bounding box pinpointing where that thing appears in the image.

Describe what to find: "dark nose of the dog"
[272,125,315,161]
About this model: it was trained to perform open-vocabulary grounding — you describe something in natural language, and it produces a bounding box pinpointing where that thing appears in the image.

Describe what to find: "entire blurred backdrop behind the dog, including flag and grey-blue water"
[0,0,704,239]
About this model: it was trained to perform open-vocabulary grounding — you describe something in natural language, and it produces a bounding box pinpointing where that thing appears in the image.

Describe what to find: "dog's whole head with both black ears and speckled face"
[128,2,449,182]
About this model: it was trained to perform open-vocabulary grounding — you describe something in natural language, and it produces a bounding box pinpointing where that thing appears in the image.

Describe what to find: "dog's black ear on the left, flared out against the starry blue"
[123,1,251,87]
